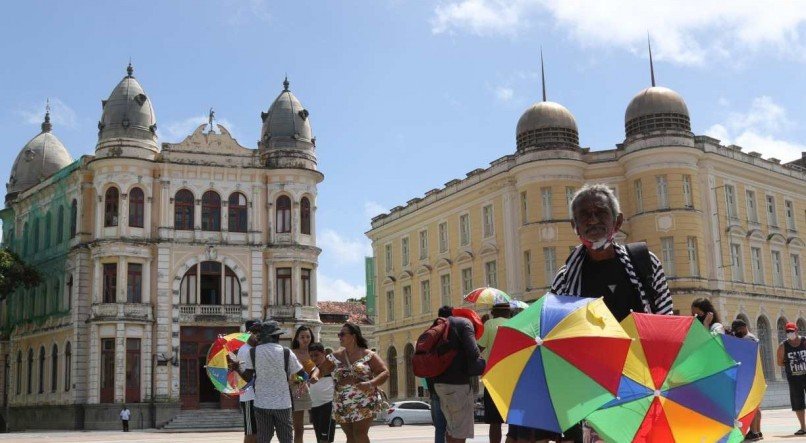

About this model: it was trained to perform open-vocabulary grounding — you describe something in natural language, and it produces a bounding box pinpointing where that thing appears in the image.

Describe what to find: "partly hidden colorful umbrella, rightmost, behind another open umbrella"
[719,335,767,442]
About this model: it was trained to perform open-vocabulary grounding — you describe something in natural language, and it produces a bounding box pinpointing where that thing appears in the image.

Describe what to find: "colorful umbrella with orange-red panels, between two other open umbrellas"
[588,313,738,442]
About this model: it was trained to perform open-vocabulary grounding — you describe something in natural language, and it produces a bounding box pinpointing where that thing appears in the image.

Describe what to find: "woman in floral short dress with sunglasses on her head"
[319,322,389,443]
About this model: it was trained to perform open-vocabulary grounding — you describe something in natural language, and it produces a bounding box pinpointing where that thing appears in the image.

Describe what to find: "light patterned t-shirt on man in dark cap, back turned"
[244,343,302,409]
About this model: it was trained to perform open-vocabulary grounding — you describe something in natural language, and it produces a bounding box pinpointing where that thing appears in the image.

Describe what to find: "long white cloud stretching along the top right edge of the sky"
[431,0,806,65]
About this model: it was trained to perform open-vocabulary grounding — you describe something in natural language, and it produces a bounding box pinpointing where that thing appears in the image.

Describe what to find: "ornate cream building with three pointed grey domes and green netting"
[0,66,323,429]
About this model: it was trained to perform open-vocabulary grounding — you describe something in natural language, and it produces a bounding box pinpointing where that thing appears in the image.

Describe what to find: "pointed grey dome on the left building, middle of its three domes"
[96,63,157,154]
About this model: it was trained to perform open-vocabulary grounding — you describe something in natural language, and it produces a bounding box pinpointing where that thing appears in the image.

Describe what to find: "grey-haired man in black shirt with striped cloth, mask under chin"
[548,184,673,441]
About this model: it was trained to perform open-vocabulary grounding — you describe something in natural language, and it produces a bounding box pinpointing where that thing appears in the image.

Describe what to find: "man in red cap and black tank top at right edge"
[778,322,806,435]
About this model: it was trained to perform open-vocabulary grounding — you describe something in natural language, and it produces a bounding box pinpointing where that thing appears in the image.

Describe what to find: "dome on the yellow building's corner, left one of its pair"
[517,101,579,151]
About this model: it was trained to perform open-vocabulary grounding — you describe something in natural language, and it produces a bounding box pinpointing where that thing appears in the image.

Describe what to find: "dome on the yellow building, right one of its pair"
[624,86,691,138]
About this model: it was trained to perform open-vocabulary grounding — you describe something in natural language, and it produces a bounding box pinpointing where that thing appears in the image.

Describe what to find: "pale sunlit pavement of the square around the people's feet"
[0,409,806,443]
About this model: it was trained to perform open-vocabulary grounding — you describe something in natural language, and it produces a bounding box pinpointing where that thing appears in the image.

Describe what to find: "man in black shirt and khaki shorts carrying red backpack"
[432,306,485,443]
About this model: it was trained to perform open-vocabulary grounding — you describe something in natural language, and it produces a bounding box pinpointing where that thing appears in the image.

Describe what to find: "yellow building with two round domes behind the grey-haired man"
[367,79,806,398]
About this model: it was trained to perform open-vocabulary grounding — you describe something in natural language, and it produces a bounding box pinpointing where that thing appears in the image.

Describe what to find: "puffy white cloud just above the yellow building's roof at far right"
[705,96,806,162]
